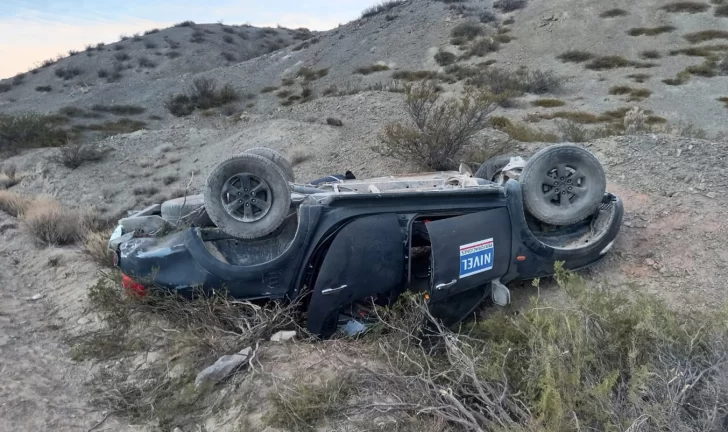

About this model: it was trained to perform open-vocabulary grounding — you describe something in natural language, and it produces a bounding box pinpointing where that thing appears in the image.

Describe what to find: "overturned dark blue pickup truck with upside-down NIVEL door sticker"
[109,145,623,337]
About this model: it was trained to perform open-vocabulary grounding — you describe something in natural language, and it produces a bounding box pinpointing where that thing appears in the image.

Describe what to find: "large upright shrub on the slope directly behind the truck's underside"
[376,82,500,170]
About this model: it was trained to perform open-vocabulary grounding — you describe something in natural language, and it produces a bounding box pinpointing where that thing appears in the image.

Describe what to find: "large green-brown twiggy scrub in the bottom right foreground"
[342,265,728,432]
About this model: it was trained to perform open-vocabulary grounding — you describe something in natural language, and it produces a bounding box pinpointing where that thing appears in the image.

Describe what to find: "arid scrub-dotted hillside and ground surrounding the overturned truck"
[0,0,728,432]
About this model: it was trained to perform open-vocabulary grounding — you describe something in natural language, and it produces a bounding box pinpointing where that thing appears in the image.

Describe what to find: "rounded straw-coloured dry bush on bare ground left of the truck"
[21,196,85,245]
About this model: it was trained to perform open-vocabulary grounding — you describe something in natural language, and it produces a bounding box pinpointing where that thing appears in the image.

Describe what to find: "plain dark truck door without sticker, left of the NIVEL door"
[307,214,405,337]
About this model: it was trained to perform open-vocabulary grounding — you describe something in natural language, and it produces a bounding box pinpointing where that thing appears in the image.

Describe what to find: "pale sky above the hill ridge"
[0,0,378,78]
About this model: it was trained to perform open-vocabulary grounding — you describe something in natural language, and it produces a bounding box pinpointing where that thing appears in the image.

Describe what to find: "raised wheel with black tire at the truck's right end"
[519,144,607,225]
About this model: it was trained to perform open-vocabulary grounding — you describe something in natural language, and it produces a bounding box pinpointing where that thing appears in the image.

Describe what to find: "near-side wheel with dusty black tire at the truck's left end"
[204,153,291,239]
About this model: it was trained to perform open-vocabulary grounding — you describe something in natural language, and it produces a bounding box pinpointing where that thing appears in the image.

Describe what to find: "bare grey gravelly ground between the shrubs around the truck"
[0,0,728,432]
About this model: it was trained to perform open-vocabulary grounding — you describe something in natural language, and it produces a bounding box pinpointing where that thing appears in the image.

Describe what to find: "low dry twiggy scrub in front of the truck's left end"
[74,273,303,430]
